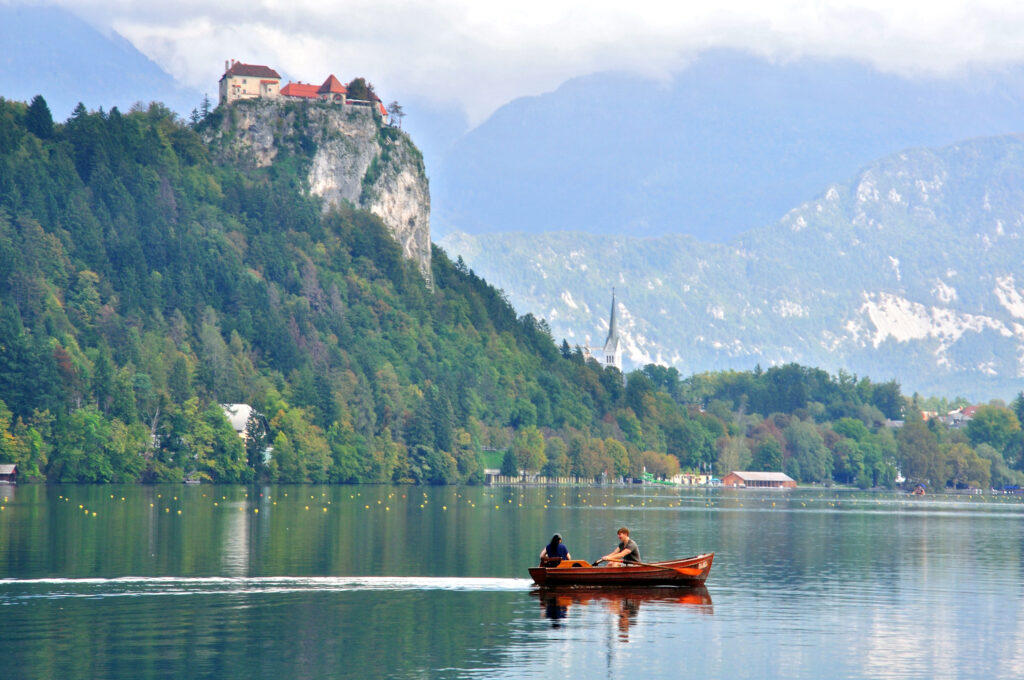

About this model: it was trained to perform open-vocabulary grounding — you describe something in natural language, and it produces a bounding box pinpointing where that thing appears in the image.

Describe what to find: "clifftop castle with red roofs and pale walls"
[220,59,388,121]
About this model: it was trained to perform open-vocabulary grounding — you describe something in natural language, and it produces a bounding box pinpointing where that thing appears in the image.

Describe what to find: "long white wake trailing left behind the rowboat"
[0,577,530,605]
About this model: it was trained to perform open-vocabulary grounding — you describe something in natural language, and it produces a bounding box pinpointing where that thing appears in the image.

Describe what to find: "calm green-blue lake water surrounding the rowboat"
[0,485,1024,679]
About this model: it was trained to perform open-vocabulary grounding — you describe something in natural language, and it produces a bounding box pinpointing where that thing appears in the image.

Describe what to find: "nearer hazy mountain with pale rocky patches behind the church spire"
[441,135,1024,395]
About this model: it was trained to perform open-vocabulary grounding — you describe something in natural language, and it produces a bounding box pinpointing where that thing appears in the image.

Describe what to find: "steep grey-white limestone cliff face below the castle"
[206,99,430,281]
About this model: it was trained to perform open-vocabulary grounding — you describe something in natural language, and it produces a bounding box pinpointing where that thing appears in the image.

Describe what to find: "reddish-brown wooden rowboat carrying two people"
[529,553,715,588]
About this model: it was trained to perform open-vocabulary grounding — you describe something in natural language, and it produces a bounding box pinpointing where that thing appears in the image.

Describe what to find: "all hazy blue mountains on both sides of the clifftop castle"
[8,5,1024,397]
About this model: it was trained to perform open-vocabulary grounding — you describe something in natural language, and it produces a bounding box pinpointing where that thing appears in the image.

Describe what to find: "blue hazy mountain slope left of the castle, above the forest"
[0,4,201,120]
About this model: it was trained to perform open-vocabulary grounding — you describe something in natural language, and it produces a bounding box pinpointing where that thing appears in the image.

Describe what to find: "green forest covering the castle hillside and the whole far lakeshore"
[0,97,1024,493]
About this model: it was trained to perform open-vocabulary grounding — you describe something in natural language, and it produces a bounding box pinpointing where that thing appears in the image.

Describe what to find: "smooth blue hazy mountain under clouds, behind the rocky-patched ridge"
[428,50,1024,242]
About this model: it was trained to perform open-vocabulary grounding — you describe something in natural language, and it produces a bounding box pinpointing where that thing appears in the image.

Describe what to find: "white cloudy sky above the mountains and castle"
[46,0,1024,123]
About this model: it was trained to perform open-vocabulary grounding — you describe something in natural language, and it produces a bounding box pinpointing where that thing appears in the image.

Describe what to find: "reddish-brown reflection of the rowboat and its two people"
[532,586,715,642]
